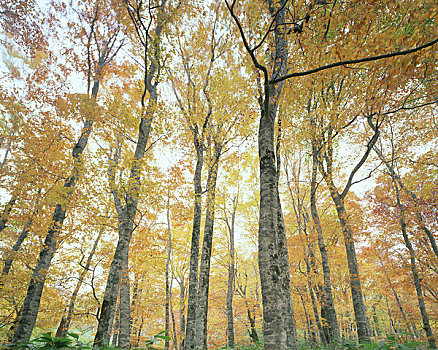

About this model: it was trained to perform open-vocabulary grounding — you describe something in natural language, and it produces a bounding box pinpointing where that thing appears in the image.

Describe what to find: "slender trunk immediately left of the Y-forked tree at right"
[310,148,341,343]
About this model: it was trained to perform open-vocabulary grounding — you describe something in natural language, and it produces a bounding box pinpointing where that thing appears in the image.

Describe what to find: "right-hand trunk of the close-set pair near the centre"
[195,142,222,350]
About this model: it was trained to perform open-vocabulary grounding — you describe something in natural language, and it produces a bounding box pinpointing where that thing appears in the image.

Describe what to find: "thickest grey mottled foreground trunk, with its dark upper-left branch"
[226,0,296,350]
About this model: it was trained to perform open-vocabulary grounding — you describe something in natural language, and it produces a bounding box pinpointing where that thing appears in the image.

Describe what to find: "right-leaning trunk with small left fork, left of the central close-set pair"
[93,6,165,348]
